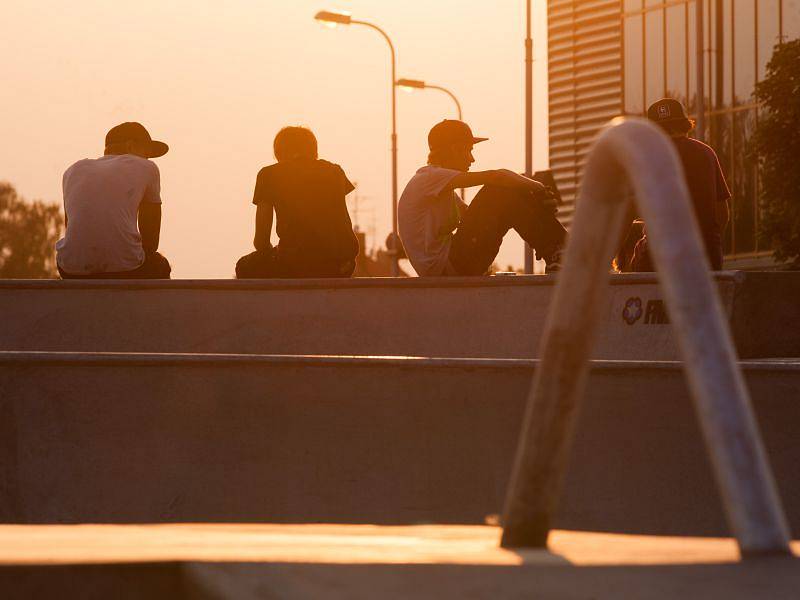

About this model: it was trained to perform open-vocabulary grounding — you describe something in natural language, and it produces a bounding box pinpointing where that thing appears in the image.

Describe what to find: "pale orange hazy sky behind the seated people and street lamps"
[0,0,547,278]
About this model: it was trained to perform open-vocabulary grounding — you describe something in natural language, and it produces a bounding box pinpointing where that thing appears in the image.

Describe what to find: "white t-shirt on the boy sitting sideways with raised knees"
[397,165,466,277]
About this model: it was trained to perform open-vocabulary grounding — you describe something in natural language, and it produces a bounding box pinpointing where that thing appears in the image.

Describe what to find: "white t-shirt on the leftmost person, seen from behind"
[56,154,161,275]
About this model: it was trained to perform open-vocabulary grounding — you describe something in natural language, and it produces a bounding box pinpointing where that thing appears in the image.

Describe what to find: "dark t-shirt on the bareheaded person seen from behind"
[253,159,358,261]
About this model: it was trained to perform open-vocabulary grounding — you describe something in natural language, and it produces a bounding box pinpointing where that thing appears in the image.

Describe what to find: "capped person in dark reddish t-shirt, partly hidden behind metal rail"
[631,98,731,271]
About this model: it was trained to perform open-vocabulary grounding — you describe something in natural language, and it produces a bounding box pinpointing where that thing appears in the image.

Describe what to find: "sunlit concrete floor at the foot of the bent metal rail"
[0,524,800,600]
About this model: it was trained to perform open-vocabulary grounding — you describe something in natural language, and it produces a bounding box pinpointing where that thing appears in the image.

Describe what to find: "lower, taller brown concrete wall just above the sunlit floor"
[0,353,800,535]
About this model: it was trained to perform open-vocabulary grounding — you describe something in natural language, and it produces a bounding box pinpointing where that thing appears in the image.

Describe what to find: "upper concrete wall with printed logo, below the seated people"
[0,273,800,360]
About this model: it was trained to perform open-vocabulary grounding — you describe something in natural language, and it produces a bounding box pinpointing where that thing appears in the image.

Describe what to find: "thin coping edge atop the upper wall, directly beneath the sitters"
[0,271,746,291]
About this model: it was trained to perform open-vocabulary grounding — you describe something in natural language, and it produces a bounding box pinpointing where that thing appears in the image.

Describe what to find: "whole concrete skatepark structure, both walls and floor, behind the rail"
[0,117,800,598]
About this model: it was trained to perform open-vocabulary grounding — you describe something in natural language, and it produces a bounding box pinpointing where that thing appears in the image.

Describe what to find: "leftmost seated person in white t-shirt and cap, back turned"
[56,123,172,279]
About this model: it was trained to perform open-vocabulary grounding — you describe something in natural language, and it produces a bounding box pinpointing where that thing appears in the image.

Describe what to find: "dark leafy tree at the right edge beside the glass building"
[754,39,800,268]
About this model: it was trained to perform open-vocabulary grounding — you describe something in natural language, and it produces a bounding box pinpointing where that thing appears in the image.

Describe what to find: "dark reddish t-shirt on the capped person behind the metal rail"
[673,137,731,245]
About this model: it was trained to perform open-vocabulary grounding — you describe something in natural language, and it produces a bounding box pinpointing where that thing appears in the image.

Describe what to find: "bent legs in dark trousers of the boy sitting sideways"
[449,185,567,275]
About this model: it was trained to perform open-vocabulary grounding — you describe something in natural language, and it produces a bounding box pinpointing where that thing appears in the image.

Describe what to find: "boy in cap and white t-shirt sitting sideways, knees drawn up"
[398,120,567,277]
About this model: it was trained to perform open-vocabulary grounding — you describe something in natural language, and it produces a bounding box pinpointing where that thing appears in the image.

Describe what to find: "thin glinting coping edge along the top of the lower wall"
[0,350,800,371]
